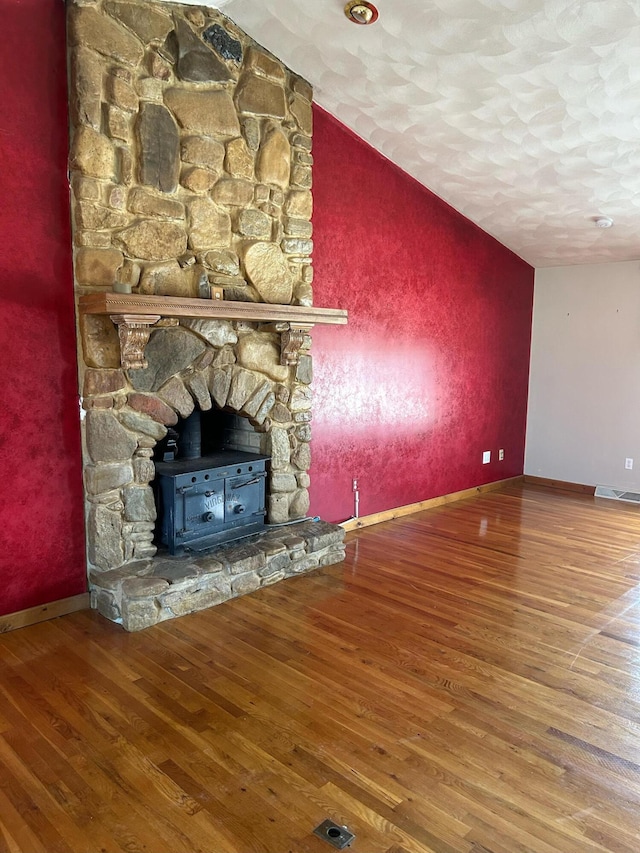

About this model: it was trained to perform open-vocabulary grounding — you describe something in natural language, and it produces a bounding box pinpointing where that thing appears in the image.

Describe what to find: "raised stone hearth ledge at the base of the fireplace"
[89,521,345,631]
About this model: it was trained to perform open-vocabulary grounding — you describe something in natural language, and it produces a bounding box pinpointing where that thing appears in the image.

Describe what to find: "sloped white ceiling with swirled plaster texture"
[172,0,640,267]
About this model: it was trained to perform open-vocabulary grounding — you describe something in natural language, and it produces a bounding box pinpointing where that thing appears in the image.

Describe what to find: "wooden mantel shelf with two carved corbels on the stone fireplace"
[79,292,347,370]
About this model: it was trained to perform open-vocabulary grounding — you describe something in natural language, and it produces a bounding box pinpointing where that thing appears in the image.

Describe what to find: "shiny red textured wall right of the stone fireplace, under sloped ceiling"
[311,109,534,521]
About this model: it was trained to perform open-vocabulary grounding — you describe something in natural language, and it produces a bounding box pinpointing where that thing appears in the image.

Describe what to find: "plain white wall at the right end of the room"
[525,261,640,491]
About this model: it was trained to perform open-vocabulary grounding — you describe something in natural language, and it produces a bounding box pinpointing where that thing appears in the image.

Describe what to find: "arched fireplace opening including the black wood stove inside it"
[154,410,269,555]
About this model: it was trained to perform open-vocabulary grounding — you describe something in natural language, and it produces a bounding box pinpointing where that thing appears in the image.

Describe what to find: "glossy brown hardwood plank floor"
[0,485,640,853]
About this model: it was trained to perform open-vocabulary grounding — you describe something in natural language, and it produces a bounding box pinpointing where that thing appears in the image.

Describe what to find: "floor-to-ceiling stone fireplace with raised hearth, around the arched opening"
[69,0,344,630]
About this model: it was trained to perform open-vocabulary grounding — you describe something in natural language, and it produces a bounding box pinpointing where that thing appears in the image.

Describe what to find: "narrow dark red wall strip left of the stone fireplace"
[0,0,86,614]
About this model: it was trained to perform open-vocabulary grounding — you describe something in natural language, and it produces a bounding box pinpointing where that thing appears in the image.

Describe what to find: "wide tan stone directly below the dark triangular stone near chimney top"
[164,87,240,137]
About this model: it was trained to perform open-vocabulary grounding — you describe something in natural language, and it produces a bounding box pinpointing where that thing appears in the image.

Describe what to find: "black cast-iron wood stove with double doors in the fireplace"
[156,450,269,554]
